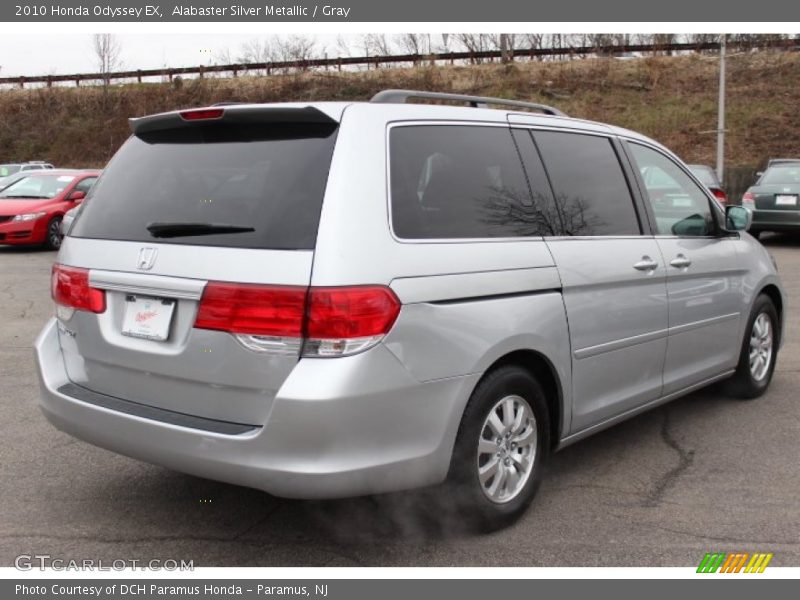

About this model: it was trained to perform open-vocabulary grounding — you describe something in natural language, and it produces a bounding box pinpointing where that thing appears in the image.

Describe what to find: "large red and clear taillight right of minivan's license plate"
[195,282,400,356]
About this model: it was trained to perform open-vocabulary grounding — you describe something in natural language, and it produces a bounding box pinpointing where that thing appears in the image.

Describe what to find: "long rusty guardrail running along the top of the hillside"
[0,39,800,88]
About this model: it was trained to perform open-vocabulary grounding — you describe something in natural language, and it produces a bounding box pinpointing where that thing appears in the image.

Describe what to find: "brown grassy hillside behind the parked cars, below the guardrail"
[0,52,800,197]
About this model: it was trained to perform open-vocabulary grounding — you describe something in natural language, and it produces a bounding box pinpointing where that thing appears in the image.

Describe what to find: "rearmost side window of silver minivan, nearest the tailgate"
[389,125,552,239]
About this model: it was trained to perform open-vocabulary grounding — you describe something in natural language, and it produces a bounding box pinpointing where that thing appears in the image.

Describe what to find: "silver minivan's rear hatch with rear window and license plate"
[54,105,344,425]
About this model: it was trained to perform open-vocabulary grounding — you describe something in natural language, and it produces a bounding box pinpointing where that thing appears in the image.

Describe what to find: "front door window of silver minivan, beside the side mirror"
[628,143,714,236]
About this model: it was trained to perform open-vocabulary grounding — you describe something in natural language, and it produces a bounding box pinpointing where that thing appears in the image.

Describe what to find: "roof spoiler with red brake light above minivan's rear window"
[128,105,339,135]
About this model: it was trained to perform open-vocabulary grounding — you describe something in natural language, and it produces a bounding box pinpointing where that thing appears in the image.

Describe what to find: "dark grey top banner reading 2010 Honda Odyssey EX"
[0,0,800,23]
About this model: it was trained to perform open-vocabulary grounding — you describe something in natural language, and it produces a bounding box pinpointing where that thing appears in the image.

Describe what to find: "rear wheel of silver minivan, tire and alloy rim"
[445,365,550,531]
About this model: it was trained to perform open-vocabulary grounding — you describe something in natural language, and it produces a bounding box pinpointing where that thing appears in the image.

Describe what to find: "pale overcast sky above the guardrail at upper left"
[0,32,350,77]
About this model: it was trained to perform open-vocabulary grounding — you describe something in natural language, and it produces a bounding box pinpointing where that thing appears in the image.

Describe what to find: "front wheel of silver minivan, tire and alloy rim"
[726,294,781,400]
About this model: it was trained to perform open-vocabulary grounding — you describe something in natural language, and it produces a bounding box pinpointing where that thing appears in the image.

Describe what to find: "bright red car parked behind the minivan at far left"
[0,169,100,250]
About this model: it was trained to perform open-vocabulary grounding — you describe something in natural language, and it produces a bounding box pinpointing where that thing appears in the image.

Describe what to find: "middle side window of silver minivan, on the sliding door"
[533,131,641,236]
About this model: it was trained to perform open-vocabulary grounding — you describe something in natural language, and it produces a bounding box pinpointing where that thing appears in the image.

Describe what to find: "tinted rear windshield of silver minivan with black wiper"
[70,123,336,250]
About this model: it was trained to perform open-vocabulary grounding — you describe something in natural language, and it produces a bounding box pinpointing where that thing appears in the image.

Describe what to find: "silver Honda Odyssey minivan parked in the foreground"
[35,90,784,526]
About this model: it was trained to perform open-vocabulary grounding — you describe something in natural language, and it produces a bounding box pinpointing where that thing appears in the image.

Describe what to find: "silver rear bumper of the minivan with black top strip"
[35,319,478,498]
